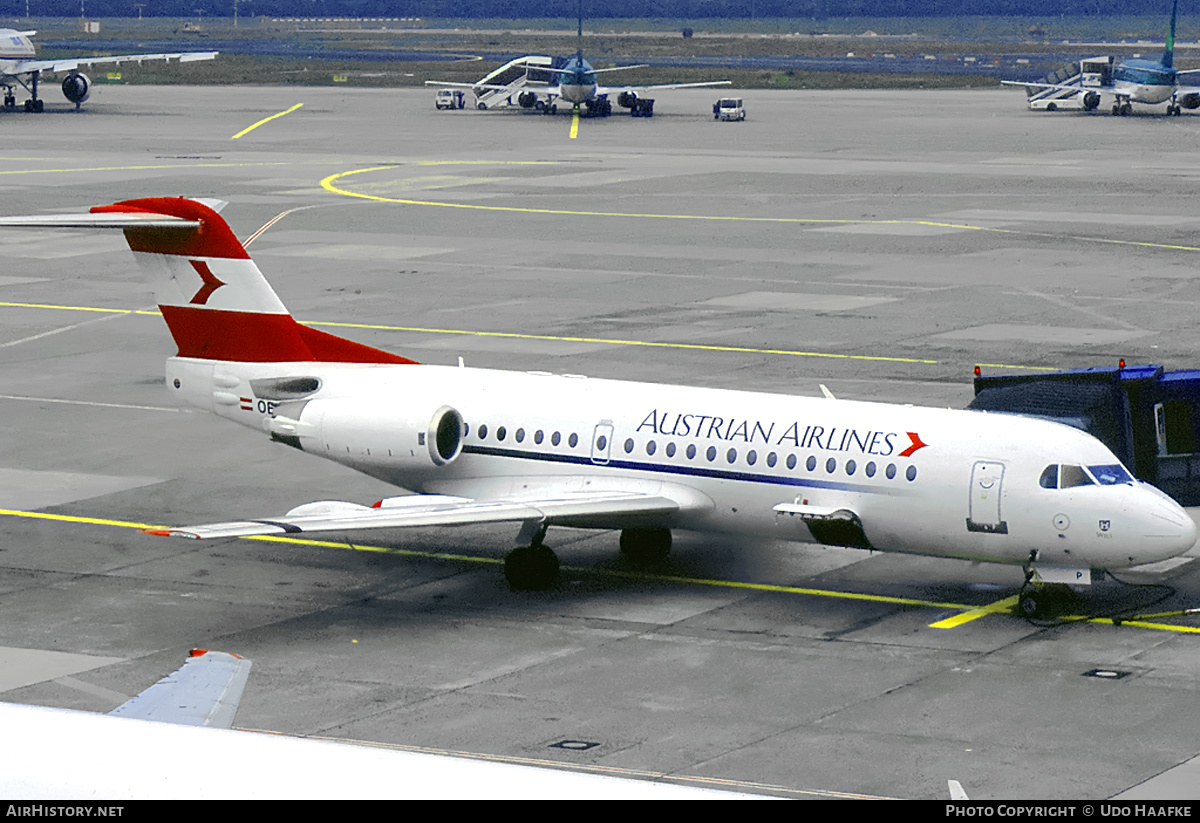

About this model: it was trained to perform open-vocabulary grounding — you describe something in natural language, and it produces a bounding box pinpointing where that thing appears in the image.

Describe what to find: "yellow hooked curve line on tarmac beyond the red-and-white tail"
[320,161,1200,252]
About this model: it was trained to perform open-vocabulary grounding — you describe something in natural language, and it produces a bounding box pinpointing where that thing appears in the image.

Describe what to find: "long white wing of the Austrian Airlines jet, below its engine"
[144,491,706,539]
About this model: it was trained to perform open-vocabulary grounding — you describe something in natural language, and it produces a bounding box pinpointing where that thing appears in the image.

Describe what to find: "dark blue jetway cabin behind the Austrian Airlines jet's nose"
[967,365,1200,506]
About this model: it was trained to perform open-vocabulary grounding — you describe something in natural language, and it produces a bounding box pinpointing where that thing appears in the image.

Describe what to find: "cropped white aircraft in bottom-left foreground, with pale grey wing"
[0,651,748,800]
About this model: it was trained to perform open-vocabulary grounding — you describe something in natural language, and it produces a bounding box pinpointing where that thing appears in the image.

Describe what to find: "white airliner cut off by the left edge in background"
[0,29,217,112]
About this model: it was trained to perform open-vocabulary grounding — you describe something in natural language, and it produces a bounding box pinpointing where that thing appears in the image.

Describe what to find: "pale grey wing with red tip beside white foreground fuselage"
[108,649,250,728]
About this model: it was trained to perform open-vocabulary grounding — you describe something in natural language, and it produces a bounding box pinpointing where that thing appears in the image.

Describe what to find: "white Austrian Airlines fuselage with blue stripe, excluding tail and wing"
[167,358,1196,578]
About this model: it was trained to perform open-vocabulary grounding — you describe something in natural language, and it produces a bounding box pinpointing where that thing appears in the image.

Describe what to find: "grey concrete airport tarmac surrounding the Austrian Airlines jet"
[0,86,1200,799]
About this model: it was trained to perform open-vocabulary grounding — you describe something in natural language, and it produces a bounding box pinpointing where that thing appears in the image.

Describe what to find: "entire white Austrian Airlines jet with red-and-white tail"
[0,198,1196,611]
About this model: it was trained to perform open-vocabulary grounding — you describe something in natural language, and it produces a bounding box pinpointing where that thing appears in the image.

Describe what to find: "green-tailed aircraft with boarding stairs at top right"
[1001,0,1200,114]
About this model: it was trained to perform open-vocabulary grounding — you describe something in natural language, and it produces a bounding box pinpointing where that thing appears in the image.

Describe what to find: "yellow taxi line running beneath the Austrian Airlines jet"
[0,509,1200,633]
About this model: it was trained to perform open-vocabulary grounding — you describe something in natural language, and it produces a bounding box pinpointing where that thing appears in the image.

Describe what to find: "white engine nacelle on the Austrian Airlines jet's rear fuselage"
[278,398,467,474]
